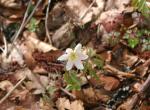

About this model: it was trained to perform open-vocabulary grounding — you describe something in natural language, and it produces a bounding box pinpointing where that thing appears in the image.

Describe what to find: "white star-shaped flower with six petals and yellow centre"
[58,44,88,70]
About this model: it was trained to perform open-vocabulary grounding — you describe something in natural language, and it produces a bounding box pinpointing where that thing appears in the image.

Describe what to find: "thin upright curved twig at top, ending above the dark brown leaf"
[45,0,52,45]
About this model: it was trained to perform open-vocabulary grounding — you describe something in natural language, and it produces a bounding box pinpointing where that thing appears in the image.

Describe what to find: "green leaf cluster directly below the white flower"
[64,70,81,90]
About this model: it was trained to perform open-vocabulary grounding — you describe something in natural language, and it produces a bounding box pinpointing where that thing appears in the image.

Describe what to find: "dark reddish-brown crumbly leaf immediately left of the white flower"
[33,50,64,73]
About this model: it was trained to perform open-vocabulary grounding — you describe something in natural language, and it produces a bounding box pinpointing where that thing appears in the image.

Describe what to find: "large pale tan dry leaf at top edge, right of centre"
[66,0,104,25]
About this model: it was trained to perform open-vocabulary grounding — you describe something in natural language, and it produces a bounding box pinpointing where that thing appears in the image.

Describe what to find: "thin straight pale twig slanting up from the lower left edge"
[0,76,26,104]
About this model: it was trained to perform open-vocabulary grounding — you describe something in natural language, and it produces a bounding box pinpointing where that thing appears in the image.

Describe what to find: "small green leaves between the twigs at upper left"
[27,18,39,32]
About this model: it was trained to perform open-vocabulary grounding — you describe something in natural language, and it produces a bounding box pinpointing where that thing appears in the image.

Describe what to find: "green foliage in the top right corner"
[132,0,150,17]
